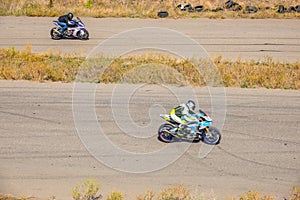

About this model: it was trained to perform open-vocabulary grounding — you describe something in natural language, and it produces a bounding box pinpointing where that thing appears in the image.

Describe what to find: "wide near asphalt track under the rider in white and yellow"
[0,81,300,199]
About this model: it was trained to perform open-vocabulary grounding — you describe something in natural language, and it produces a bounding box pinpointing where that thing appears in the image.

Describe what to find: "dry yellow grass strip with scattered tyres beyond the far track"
[0,0,300,18]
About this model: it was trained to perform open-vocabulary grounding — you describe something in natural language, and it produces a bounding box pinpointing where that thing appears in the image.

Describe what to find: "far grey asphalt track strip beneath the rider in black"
[0,17,300,62]
